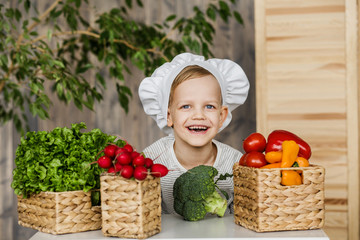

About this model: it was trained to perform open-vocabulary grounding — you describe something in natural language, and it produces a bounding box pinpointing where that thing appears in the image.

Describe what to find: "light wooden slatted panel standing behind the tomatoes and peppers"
[255,0,359,239]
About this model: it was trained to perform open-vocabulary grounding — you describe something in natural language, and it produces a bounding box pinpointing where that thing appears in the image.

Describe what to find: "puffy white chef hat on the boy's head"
[139,53,249,134]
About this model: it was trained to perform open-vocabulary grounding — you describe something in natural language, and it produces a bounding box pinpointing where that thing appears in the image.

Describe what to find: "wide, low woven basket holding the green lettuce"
[18,191,101,234]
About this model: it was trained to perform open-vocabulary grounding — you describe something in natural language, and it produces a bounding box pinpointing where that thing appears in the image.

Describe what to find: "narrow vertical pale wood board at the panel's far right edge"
[345,0,360,239]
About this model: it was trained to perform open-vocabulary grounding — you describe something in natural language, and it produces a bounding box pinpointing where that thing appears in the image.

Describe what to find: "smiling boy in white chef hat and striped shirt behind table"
[139,53,249,214]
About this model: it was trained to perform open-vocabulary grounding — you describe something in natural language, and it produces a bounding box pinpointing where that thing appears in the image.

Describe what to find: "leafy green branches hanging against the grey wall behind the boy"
[0,0,243,133]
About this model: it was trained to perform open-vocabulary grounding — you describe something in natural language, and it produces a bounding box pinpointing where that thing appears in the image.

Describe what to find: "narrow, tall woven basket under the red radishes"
[100,174,161,239]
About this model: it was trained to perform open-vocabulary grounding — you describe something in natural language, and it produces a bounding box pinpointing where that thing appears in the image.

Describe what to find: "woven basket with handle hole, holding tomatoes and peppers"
[233,163,325,232]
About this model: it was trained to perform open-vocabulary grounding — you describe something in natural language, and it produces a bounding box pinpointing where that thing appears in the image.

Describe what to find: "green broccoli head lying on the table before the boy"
[173,165,227,221]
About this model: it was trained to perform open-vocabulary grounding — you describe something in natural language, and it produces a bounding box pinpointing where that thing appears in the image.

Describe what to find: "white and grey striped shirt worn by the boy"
[143,136,242,214]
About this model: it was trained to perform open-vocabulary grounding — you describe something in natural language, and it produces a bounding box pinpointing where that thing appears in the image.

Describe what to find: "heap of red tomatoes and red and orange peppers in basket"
[239,130,311,186]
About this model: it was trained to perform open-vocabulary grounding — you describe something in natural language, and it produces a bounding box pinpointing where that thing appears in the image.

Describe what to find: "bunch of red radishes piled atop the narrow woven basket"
[96,143,169,180]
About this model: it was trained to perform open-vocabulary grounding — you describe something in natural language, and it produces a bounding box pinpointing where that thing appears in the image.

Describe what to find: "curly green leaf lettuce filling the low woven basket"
[11,123,125,198]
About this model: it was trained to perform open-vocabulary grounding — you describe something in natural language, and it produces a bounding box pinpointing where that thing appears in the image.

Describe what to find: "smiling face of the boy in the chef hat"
[167,75,228,147]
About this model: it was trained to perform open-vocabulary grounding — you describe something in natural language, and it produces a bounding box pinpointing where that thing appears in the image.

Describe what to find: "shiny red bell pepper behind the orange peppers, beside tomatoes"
[265,130,311,159]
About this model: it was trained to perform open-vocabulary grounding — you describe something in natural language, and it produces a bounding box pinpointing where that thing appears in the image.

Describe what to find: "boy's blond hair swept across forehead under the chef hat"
[168,65,215,106]
